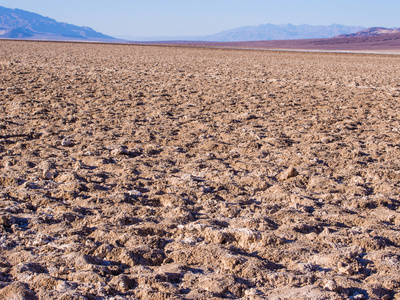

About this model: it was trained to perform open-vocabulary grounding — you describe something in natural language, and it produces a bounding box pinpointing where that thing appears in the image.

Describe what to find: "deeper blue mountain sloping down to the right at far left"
[0,6,116,41]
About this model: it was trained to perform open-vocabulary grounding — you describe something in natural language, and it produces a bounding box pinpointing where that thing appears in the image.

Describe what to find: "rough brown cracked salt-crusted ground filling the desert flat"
[0,41,400,300]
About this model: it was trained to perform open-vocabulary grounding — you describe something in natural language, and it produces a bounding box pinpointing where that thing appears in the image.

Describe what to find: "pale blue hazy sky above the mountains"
[0,0,400,36]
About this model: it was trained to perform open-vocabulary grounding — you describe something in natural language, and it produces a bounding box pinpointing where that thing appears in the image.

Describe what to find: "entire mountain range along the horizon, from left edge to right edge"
[0,6,400,45]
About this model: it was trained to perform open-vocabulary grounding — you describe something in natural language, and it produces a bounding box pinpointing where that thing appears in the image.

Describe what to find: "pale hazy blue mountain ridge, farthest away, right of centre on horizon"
[203,24,364,42]
